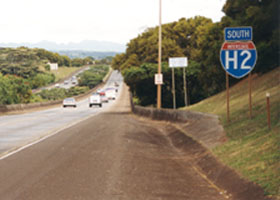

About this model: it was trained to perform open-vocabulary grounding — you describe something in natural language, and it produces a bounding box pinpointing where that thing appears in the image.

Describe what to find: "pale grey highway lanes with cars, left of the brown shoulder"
[0,71,122,158]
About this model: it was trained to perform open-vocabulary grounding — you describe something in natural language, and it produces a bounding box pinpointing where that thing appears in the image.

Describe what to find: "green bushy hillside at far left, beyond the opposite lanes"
[0,47,93,105]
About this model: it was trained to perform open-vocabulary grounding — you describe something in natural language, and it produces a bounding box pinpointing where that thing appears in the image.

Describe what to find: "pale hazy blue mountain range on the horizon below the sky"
[0,40,125,52]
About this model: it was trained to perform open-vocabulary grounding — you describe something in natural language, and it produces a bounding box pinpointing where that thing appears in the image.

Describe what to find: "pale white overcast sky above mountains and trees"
[0,0,226,44]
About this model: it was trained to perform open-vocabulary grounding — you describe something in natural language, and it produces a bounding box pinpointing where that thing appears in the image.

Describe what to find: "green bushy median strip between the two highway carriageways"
[36,65,109,101]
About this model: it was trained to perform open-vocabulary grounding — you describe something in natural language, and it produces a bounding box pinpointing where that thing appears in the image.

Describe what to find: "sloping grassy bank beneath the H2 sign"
[187,67,280,199]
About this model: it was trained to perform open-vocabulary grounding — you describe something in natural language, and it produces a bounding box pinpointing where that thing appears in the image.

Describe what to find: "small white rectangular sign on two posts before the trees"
[169,57,188,109]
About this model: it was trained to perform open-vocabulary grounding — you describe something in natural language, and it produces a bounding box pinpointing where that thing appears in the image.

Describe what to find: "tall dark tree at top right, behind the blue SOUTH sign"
[223,0,280,72]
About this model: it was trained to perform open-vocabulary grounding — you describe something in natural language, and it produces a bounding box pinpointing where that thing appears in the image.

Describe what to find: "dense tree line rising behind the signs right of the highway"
[112,0,280,107]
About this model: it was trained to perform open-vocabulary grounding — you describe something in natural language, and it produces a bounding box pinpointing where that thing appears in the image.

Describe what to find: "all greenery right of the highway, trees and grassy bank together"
[112,0,280,199]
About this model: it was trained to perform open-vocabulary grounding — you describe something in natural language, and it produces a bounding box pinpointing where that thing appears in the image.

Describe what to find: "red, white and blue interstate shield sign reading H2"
[220,41,257,78]
